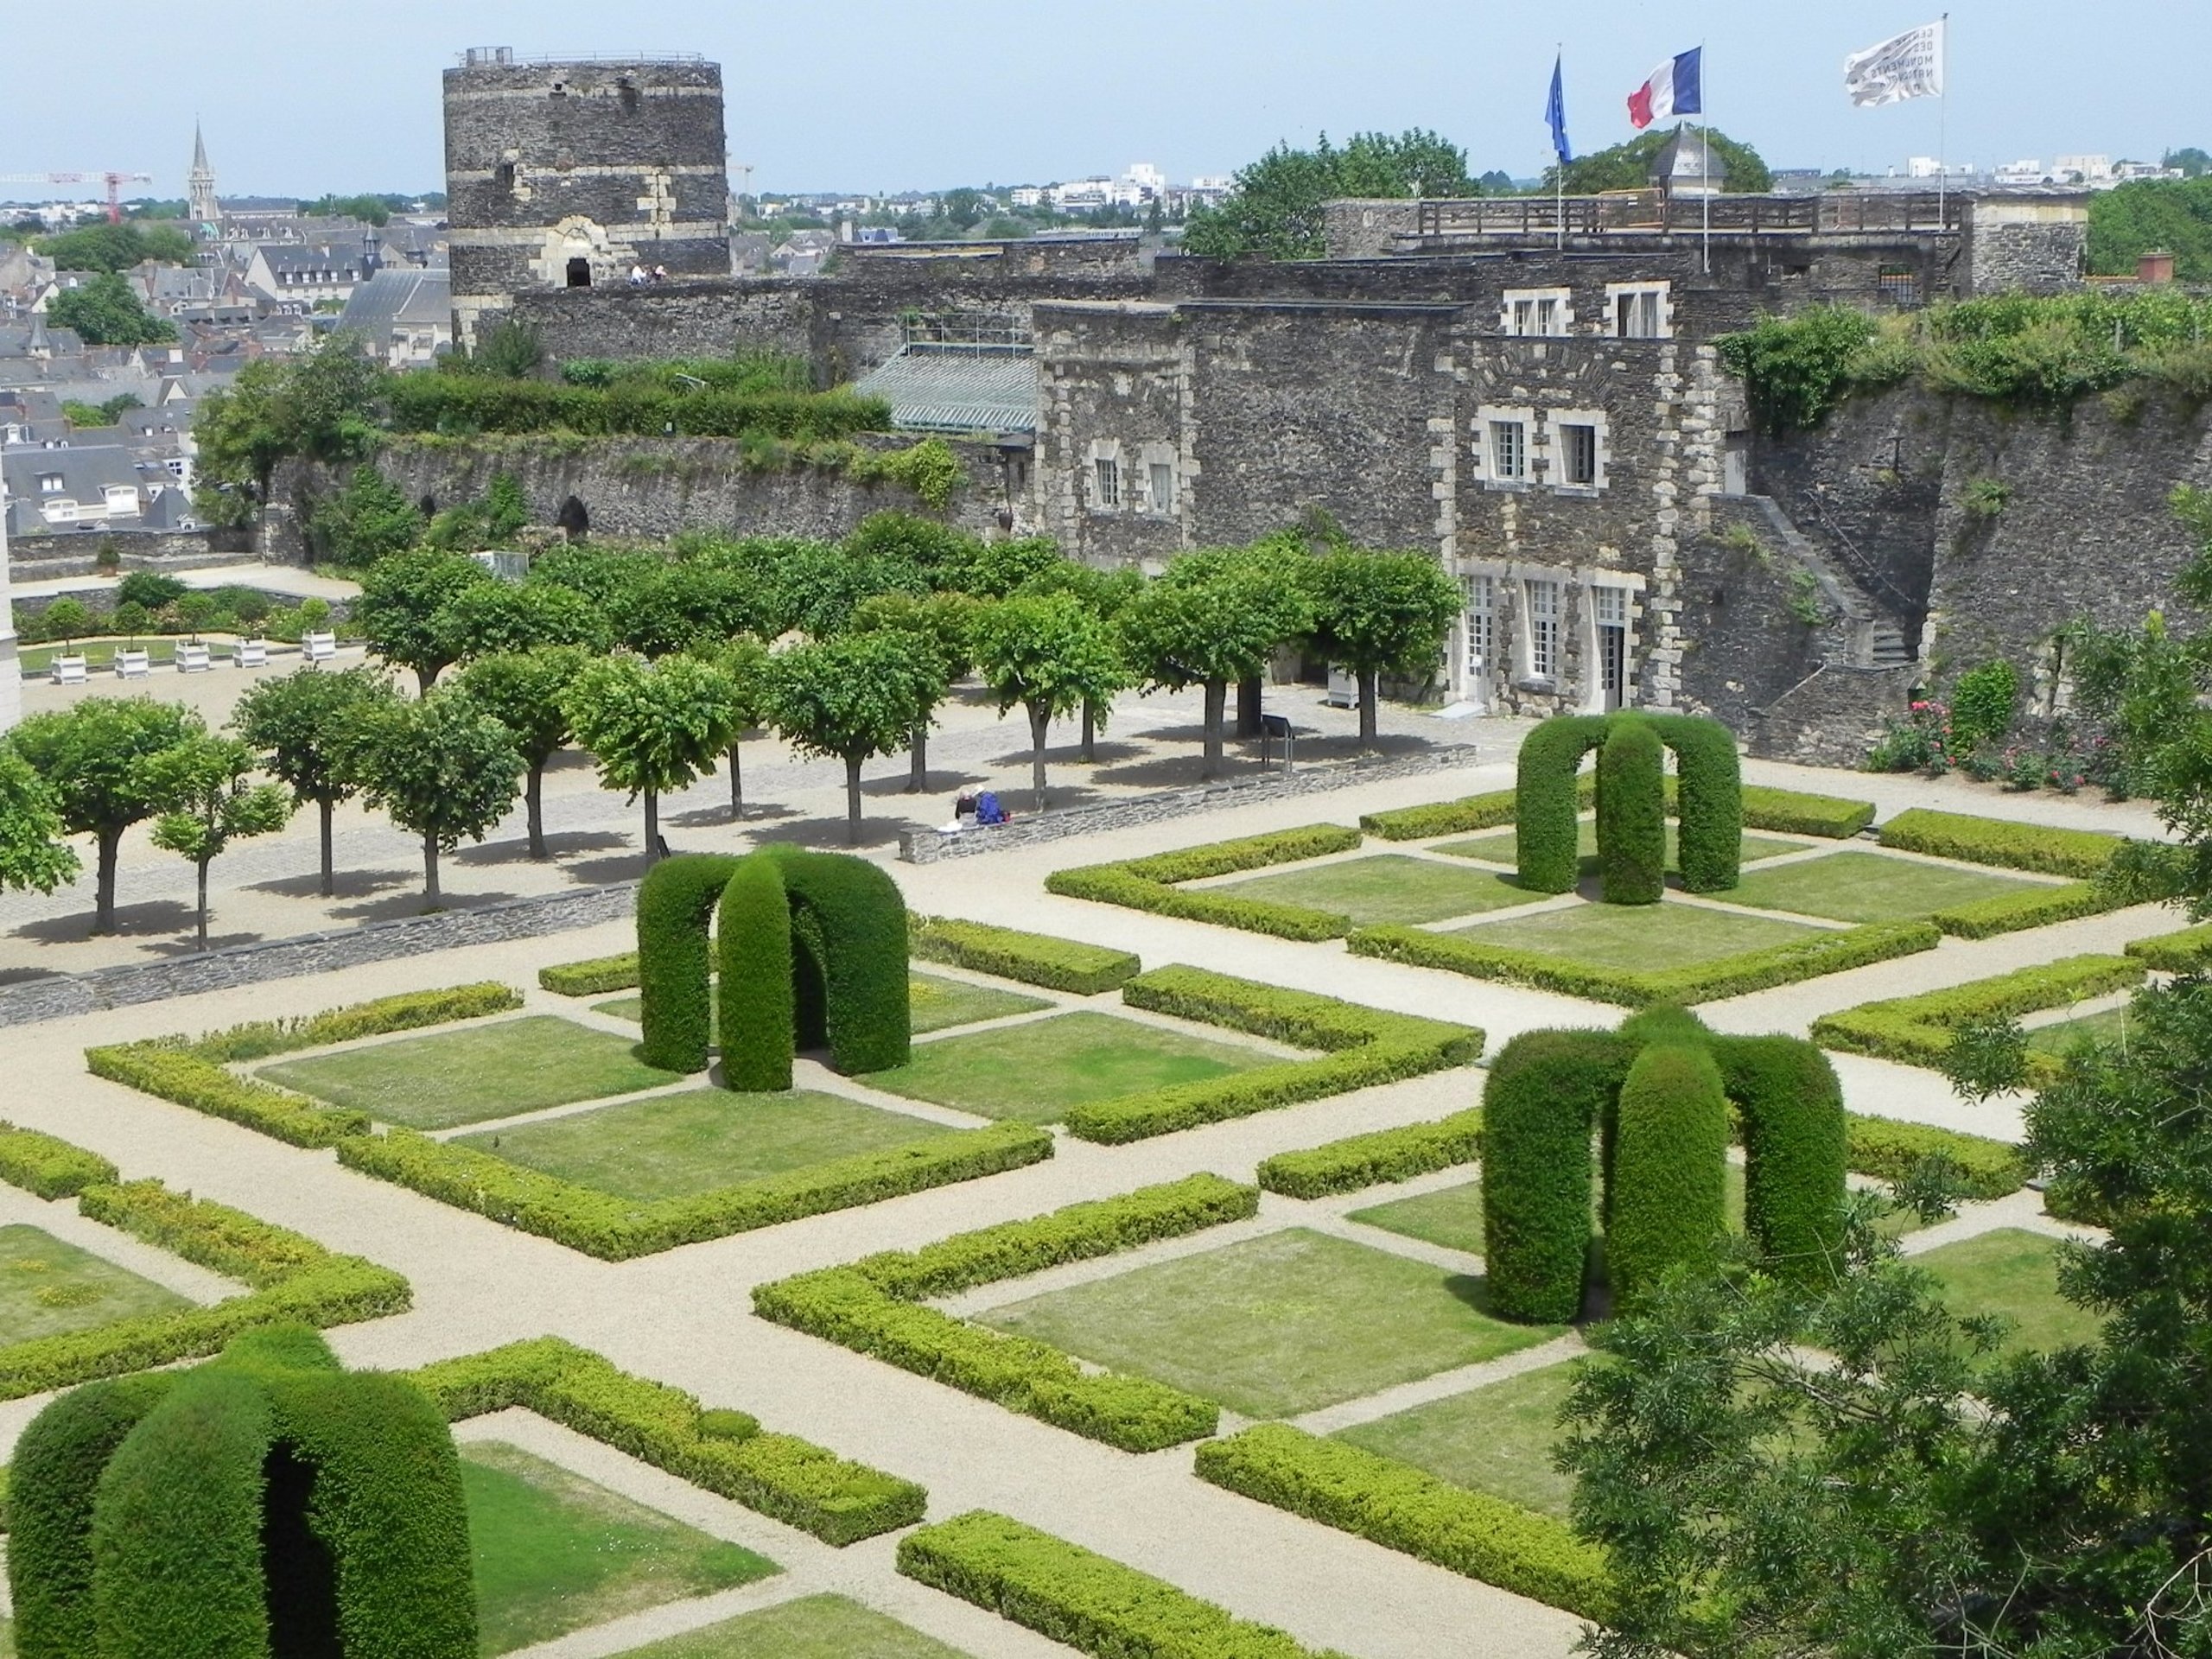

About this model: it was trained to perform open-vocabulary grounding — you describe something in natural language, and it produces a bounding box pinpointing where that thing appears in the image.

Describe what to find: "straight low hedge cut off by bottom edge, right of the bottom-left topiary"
[898,1509,1344,1659]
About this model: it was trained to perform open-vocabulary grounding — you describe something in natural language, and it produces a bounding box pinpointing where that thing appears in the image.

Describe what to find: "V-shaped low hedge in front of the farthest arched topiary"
[1344,923,1942,1008]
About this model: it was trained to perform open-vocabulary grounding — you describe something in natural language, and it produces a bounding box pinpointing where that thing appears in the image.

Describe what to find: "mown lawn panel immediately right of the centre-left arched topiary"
[868,1008,1276,1123]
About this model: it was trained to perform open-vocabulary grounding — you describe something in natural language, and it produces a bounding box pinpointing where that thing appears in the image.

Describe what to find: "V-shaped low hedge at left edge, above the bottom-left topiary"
[0,1159,411,1400]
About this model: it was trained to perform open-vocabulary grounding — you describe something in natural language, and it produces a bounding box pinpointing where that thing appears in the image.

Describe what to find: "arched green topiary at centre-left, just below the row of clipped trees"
[637,845,912,1090]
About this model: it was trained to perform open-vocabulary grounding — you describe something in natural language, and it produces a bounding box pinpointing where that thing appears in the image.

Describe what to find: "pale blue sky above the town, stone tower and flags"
[0,0,2212,194]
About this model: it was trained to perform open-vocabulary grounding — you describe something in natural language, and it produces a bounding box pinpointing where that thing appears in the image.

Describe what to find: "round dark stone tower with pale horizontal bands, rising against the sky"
[445,47,730,343]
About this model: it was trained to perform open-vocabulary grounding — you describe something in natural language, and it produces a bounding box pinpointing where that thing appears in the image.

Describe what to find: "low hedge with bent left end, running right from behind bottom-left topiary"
[410,1336,929,1546]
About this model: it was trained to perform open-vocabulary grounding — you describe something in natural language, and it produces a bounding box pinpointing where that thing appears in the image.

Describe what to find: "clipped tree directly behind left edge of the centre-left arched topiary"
[562,652,741,858]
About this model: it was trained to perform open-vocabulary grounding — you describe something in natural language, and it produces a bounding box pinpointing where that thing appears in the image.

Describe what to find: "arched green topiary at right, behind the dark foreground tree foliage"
[1482,1008,1845,1323]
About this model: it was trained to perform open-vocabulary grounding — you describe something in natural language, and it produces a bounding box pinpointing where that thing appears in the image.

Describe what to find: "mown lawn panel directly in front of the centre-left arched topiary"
[460,1089,953,1199]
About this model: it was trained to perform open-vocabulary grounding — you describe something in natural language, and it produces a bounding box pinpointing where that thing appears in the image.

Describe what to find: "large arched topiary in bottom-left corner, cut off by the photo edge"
[9,1327,475,1659]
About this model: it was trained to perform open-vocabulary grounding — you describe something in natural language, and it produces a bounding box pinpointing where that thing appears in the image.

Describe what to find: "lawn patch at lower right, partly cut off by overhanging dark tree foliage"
[1336,1360,1581,1520]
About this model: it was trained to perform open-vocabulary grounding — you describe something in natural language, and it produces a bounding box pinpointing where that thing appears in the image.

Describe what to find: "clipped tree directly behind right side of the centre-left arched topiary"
[767,631,944,845]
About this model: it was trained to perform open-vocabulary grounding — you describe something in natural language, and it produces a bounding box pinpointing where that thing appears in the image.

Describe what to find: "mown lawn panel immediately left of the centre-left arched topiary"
[261,1013,679,1128]
